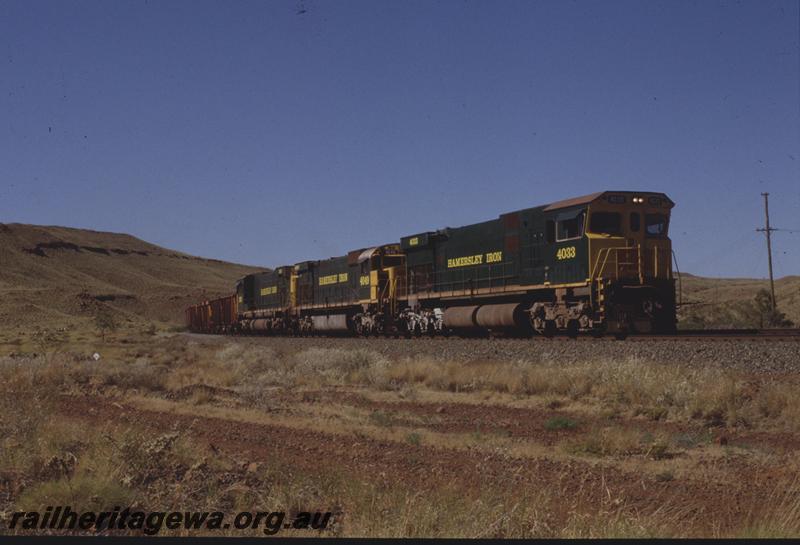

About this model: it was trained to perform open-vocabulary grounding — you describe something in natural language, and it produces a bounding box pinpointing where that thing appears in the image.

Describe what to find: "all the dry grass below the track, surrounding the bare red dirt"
[0,339,800,537]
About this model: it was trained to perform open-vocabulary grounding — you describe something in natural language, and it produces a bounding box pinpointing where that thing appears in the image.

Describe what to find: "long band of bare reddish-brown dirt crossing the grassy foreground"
[54,397,792,534]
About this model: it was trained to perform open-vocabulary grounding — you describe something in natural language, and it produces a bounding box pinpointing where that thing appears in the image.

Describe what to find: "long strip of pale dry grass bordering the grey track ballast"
[14,340,800,431]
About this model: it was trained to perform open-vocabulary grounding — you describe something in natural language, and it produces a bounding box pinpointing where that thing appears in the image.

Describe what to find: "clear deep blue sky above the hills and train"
[0,0,800,277]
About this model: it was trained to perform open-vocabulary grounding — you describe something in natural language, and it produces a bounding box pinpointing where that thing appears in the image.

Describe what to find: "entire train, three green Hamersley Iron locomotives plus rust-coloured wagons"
[186,191,676,336]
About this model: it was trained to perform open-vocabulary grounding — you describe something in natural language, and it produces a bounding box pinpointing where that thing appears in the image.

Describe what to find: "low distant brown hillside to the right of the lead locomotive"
[678,274,800,328]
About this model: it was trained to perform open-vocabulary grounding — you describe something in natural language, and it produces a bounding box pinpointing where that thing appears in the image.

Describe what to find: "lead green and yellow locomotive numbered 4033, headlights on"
[400,191,675,335]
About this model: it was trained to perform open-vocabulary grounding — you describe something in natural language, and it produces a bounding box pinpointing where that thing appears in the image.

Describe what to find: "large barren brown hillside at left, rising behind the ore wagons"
[0,223,259,332]
